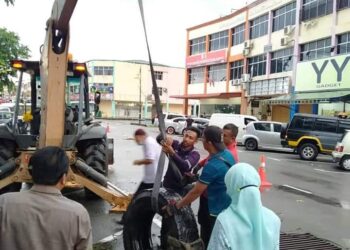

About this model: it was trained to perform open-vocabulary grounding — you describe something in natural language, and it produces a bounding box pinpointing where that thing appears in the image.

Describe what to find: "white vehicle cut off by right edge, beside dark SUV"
[332,130,350,171]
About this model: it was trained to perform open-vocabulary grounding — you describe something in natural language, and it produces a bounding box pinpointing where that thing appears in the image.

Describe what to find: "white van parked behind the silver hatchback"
[209,113,258,144]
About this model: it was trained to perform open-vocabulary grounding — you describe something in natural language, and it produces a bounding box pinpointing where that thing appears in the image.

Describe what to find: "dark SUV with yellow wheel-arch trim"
[285,114,350,161]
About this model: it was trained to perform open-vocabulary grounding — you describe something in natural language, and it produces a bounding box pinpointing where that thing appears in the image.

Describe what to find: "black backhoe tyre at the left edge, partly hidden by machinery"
[0,139,22,195]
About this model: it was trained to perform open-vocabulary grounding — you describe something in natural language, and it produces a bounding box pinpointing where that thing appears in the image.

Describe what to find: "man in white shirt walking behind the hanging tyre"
[134,129,161,196]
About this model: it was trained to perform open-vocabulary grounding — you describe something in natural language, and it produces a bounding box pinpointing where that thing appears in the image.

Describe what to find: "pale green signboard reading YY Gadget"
[295,55,350,92]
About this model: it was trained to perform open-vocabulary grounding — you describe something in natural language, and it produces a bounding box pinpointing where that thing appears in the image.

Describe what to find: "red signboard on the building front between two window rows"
[186,49,227,68]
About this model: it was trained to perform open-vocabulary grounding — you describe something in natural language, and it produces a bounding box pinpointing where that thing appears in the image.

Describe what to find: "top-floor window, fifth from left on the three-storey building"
[272,2,296,31]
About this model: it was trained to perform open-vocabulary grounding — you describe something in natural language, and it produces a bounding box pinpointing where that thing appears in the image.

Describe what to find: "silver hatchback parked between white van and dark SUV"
[242,121,284,150]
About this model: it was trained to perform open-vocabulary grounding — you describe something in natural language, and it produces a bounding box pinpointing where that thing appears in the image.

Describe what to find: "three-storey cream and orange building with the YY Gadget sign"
[182,0,350,121]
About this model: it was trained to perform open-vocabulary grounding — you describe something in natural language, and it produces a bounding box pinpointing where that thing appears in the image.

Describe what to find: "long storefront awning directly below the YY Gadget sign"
[263,91,350,105]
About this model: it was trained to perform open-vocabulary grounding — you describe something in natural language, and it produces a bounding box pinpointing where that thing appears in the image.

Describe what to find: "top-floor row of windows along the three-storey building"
[190,0,350,55]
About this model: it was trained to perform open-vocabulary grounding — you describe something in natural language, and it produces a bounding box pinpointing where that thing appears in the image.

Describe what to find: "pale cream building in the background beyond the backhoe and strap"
[87,60,191,119]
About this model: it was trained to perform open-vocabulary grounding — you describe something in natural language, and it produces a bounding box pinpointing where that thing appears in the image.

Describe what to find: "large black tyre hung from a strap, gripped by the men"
[123,188,204,250]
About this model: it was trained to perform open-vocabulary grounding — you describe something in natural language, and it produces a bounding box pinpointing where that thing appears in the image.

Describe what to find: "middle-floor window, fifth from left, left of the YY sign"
[271,48,293,74]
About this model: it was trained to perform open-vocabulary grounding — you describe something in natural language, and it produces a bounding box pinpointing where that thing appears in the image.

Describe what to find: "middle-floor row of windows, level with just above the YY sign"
[189,32,350,83]
